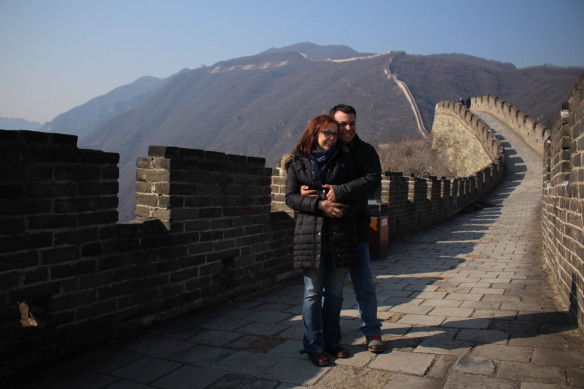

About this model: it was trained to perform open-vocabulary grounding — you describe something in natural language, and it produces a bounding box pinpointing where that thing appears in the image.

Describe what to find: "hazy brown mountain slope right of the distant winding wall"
[390,54,583,128]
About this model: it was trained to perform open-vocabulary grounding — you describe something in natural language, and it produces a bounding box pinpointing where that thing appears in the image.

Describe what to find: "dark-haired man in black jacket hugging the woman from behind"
[302,104,385,353]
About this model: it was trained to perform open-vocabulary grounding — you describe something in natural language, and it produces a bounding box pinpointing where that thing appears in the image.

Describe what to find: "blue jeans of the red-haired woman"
[302,254,349,353]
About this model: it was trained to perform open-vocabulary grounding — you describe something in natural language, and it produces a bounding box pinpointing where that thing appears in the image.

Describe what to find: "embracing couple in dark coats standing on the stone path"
[282,104,385,366]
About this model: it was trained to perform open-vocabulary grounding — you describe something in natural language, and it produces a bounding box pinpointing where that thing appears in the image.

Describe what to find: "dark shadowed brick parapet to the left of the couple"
[0,135,298,375]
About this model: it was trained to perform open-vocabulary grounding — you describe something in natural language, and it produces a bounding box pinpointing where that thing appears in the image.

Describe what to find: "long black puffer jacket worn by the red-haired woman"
[286,148,360,269]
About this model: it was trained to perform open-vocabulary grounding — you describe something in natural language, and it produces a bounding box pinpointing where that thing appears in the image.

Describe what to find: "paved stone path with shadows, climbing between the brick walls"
[9,114,584,389]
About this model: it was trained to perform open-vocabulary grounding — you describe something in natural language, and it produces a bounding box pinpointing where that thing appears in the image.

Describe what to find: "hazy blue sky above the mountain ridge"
[0,0,584,122]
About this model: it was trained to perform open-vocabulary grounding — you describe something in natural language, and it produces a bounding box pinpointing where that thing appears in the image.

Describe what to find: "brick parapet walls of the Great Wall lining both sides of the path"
[0,72,584,376]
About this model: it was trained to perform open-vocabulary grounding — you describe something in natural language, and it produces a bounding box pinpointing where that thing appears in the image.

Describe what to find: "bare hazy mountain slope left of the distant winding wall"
[80,52,419,219]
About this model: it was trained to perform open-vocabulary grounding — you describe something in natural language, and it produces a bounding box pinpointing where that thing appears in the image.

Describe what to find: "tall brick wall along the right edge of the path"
[542,73,584,325]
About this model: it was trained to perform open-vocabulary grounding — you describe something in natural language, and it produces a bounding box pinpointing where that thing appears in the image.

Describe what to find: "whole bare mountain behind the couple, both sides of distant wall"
[74,43,581,220]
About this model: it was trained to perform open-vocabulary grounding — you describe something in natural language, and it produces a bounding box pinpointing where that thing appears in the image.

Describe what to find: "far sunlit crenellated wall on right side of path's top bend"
[471,96,551,156]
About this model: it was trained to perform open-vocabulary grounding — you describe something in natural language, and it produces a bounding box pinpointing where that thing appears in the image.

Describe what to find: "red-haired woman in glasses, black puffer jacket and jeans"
[284,115,360,366]
